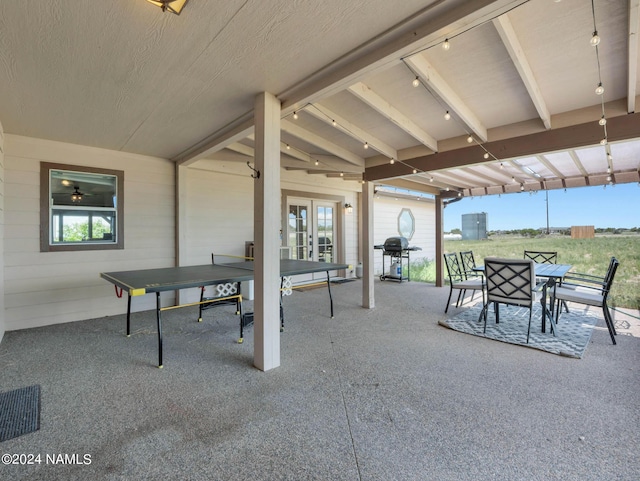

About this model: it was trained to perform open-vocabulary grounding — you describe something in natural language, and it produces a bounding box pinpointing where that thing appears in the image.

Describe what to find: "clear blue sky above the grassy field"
[444,183,640,232]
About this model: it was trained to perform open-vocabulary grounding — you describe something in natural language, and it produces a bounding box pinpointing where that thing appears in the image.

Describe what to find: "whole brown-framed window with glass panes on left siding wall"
[40,162,124,252]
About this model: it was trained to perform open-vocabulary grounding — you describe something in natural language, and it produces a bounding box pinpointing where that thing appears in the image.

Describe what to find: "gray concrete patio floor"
[0,281,640,481]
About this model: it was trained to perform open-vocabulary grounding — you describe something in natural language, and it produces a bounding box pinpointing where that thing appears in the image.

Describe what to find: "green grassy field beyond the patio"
[411,235,640,309]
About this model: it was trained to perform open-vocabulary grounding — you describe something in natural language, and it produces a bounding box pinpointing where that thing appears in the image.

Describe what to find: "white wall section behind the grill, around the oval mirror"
[373,196,436,276]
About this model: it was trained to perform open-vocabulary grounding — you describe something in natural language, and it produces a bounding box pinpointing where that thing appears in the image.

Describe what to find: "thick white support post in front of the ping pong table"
[253,92,281,371]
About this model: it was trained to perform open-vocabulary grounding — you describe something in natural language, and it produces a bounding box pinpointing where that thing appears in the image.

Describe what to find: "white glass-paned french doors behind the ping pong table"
[287,198,337,281]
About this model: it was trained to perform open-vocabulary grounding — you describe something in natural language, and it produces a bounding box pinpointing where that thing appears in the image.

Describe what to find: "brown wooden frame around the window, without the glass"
[40,162,124,252]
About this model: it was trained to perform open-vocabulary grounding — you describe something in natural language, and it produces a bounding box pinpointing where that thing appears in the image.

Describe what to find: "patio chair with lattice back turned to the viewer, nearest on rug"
[478,257,544,343]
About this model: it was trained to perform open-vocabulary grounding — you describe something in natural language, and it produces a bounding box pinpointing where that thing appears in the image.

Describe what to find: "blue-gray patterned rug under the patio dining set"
[439,304,598,358]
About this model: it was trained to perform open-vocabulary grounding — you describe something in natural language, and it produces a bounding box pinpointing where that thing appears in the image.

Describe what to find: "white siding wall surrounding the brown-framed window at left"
[3,134,175,330]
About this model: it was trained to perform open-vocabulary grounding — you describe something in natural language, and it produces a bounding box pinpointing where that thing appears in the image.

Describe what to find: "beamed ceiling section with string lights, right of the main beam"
[212,0,640,197]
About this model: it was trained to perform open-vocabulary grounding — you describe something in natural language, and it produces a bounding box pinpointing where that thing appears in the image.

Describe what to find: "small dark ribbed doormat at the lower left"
[0,384,40,442]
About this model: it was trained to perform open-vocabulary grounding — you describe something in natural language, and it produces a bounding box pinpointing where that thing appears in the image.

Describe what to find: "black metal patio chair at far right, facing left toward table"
[552,257,620,345]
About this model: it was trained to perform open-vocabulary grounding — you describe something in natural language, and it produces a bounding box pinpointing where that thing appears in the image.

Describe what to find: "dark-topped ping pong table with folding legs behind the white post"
[100,259,349,368]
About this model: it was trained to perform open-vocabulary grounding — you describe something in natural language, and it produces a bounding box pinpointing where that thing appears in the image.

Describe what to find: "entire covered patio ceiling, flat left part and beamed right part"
[0,0,640,197]
